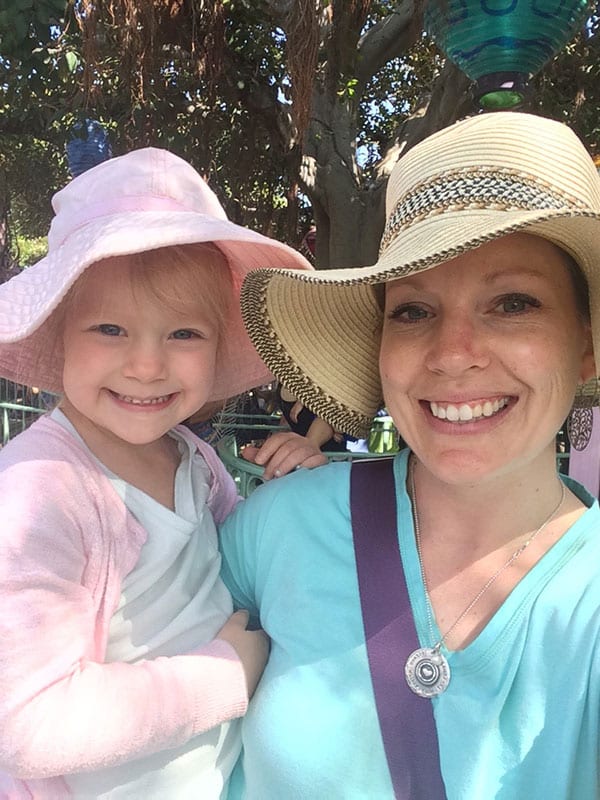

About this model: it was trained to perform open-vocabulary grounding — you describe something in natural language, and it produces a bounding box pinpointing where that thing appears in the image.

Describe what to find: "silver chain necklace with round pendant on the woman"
[404,458,566,697]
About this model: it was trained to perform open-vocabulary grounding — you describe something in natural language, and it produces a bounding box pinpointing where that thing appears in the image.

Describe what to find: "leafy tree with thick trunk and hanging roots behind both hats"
[0,0,600,267]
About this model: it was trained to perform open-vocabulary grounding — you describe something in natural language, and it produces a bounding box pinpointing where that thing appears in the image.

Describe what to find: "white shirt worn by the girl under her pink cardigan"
[52,409,240,800]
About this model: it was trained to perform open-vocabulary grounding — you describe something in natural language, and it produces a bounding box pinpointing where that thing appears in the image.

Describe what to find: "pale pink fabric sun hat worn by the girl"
[0,148,312,400]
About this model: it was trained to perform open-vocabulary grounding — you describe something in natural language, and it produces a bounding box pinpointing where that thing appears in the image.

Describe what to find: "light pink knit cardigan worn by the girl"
[0,417,248,800]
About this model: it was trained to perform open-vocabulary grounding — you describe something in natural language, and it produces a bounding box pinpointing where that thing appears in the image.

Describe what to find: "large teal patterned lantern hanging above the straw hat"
[424,0,590,111]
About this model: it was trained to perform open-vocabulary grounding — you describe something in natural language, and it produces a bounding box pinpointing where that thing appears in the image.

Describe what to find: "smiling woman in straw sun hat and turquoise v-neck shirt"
[222,113,600,800]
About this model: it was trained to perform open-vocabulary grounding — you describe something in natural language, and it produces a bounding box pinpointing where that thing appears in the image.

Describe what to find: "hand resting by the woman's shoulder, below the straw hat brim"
[242,431,327,481]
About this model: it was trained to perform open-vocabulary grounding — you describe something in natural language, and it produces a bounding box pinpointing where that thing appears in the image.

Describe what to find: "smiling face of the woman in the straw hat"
[379,233,594,483]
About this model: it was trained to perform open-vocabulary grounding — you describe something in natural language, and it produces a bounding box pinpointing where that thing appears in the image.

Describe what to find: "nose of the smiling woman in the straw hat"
[425,313,490,375]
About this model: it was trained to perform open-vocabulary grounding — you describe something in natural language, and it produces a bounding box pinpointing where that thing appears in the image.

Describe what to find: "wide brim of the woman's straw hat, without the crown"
[241,206,600,437]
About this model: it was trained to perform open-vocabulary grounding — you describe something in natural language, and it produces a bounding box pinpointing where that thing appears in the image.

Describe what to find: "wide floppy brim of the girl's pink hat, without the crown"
[0,211,312,400]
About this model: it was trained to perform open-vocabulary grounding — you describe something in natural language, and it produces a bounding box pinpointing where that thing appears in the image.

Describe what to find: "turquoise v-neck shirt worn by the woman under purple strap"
[221,451,600,800]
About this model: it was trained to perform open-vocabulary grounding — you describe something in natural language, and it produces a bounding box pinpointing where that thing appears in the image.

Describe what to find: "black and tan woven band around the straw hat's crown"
[379,167,585,257]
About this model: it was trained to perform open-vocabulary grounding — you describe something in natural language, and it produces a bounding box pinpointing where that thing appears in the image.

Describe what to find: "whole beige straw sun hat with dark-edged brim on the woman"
[242,112,600,436]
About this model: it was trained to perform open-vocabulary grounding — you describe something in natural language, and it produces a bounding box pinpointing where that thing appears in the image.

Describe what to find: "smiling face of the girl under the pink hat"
[63,259,219,454]
